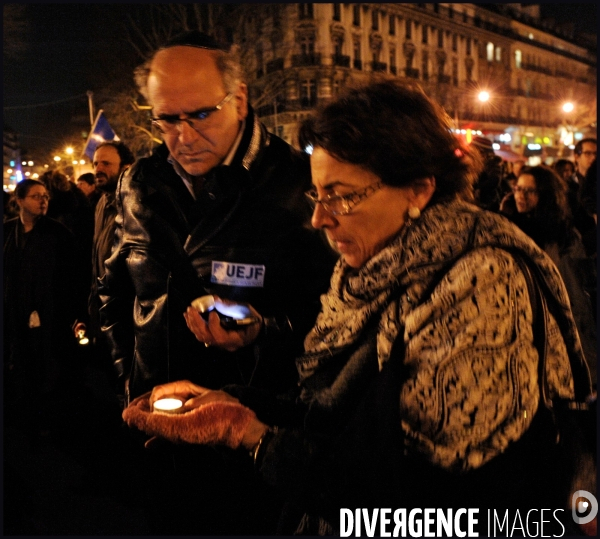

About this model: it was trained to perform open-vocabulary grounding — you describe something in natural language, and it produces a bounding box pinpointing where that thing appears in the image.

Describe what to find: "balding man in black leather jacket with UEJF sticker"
[100,32,334,535]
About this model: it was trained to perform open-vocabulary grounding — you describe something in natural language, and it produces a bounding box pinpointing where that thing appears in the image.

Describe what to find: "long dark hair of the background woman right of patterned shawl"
[519,165,572,244]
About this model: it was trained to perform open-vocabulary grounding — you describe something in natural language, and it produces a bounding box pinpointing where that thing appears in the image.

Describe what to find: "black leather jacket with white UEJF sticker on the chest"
[99,111,335,399]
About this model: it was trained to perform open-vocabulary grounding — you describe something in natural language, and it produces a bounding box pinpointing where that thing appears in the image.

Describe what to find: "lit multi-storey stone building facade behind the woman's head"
[225,3,597,162]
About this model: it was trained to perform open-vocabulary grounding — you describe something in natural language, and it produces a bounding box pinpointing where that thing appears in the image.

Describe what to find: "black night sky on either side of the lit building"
[4,3,597,159]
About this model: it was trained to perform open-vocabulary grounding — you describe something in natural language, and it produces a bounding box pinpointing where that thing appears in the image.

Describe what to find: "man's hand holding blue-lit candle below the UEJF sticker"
[183,296,262,352]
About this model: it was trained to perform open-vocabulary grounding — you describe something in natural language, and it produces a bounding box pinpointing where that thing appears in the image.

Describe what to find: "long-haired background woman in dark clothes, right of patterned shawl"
[500,165,597,384]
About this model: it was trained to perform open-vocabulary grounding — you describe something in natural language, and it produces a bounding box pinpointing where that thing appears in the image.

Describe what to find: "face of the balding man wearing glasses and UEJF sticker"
[148,46,248,176]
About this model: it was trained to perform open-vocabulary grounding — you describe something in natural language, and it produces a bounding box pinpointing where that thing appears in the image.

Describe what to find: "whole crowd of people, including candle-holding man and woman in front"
[4,31,597,535]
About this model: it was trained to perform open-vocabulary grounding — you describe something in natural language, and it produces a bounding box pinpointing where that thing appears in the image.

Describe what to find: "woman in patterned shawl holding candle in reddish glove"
[124,81,590,536]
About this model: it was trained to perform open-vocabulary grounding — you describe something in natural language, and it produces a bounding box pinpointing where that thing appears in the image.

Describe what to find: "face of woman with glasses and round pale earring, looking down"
[310,148,433,268]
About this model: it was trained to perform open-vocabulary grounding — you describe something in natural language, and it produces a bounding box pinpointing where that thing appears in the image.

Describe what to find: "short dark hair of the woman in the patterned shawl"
[299,80,481,200]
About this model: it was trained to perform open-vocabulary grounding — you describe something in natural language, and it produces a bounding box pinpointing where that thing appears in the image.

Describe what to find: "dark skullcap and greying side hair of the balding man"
[134,30,244,99]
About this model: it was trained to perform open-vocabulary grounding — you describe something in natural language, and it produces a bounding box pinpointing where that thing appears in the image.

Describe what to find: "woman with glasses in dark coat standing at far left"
[4,179,85,440]
